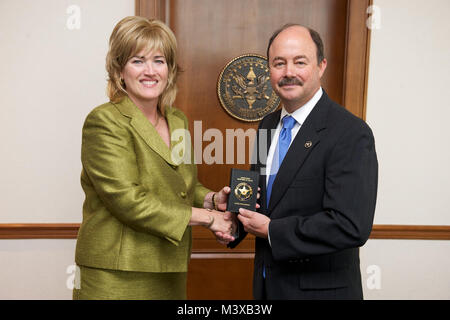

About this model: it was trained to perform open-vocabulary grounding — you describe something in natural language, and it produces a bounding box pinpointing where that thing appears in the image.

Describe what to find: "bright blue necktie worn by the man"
[266,116,297,208]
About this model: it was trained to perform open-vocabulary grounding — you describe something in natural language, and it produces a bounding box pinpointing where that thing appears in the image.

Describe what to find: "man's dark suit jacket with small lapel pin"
[230,92,378,299]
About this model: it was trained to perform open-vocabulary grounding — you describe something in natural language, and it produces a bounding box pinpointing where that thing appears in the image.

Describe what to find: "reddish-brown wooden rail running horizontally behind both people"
[0,223,450,241]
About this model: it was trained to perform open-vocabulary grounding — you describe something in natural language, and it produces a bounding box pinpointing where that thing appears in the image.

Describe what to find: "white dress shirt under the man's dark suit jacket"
[266,87,323,244]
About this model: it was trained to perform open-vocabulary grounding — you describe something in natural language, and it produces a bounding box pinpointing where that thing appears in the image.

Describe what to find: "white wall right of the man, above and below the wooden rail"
[361,0,450,299]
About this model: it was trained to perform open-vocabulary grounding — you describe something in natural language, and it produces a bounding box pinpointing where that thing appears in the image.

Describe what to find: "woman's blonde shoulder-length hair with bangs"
[106,16,179,115]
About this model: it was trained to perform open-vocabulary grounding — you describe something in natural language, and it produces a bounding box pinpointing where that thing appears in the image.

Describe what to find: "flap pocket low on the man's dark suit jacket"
[299,269,350,290]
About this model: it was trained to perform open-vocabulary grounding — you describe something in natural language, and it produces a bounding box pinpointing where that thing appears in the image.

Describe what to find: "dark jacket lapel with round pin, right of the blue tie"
[269,92,329,212]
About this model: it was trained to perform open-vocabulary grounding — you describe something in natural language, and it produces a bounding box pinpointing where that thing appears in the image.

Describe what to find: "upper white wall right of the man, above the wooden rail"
[367,0,450,225]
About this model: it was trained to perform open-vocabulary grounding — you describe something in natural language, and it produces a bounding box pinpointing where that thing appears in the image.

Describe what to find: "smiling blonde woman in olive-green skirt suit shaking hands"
[73,17,234,299]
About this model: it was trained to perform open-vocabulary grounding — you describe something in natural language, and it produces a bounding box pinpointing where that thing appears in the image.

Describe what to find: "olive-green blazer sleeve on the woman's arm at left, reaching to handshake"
[81,109,192,245]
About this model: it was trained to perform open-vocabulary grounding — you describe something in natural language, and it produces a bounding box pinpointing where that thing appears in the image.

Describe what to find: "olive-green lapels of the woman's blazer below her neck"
[116,97,179,165]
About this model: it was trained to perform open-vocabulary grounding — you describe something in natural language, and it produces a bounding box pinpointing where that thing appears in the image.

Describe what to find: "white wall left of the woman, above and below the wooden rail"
[0,0,134,300]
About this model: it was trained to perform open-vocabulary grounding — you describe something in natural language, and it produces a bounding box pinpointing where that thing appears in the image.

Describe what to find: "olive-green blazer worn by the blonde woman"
[75,97,210,272]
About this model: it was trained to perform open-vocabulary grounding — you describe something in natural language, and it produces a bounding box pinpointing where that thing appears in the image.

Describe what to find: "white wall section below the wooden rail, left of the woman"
[0,239,76,300]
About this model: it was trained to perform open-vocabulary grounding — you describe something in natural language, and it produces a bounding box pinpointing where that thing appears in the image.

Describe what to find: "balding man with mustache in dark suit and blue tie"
[229,25,378,299]
